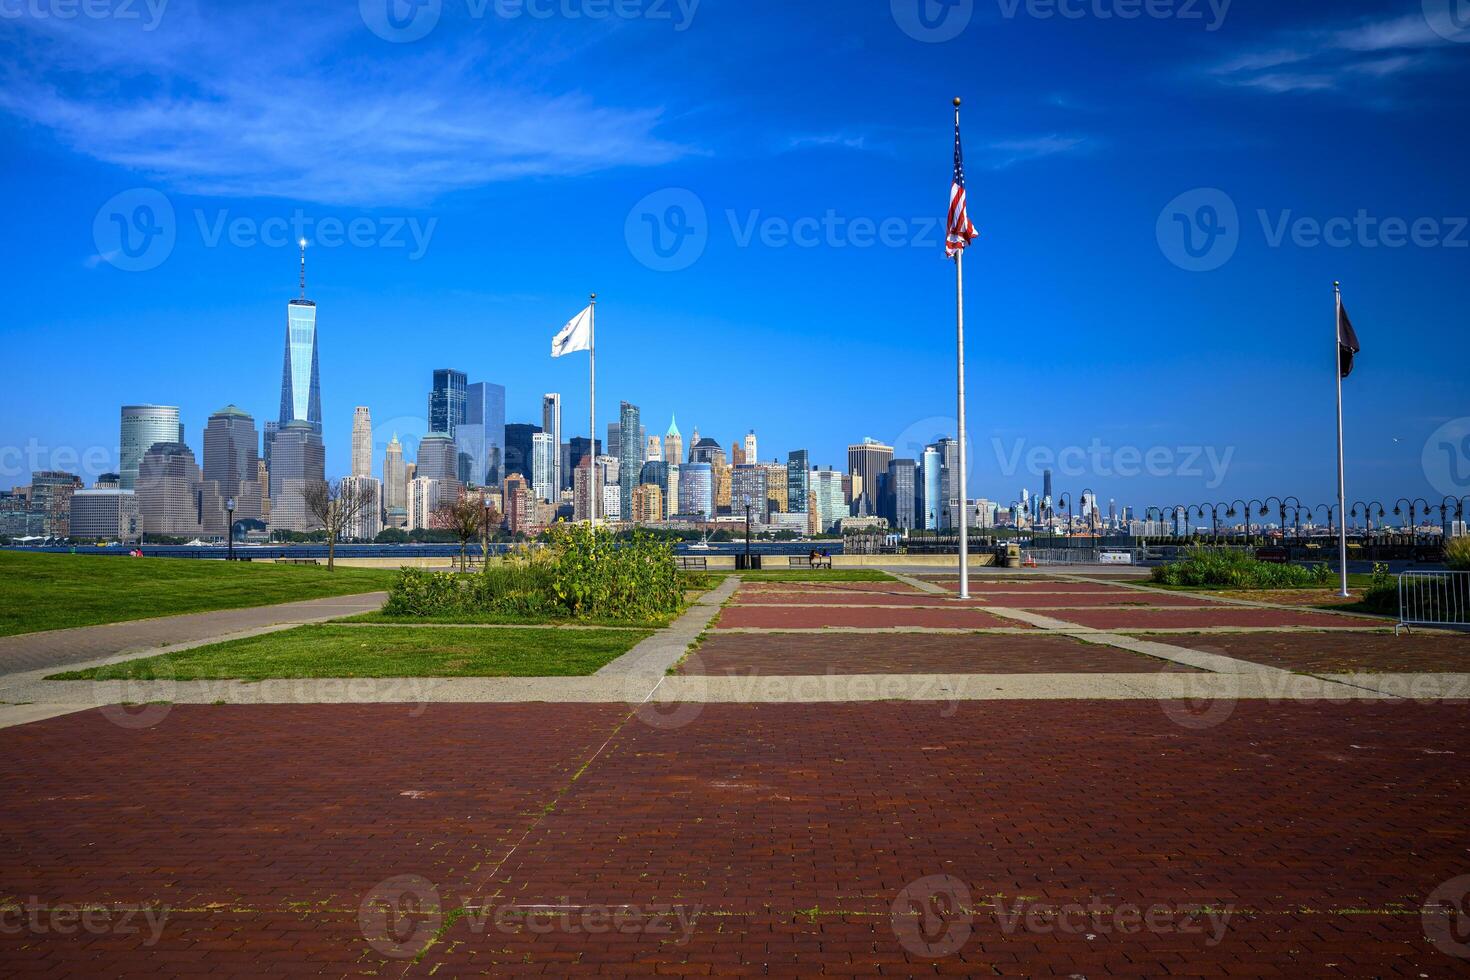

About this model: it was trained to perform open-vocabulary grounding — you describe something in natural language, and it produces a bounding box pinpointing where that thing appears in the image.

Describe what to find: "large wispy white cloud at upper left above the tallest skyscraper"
[0,4,689,207]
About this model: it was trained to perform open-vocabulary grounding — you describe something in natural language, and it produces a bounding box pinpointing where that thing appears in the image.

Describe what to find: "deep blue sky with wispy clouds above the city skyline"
[0,0,1470,508]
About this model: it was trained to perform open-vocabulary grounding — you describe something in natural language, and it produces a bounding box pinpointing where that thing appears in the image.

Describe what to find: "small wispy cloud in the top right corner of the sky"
[1208,15,1451,94]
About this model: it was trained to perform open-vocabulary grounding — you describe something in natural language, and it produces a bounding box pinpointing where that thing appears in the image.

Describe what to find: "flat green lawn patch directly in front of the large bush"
[49,624,650,680]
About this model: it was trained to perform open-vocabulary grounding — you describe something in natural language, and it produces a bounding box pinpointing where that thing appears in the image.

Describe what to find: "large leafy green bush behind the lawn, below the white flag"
[384,523,686,621]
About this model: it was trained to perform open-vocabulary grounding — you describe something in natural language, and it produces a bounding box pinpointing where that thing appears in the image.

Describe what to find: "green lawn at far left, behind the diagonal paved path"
[0,551,395,636]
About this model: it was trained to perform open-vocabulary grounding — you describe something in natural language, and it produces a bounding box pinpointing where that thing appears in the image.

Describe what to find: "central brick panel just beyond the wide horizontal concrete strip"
[679,630,1189,676]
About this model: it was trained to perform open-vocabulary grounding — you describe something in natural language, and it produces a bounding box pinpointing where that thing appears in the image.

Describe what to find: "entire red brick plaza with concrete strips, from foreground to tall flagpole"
[0,576,1470,977]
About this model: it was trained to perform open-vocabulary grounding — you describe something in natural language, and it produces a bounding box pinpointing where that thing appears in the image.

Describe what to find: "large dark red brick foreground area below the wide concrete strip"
[0,702,1470,977]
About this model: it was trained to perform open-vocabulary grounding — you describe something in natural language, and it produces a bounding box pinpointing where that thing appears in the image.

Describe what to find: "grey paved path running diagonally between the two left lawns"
[0,592,388,676]
